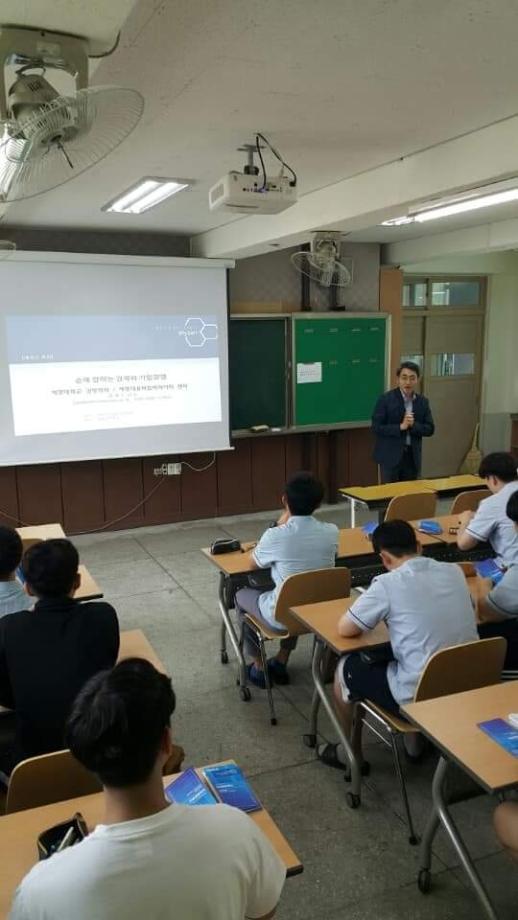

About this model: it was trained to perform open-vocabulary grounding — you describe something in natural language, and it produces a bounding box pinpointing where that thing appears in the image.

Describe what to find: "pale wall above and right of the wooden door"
[402,252,518,453]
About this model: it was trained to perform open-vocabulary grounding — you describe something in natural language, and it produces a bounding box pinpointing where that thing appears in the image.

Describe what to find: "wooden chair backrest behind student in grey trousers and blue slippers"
[275,566,351,636]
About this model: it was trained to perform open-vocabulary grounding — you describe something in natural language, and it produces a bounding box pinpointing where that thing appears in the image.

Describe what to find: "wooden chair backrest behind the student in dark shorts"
[414,636,507,703]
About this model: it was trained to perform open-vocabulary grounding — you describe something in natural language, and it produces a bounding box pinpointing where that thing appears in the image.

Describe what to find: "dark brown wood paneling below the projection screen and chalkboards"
[0,428,377,534]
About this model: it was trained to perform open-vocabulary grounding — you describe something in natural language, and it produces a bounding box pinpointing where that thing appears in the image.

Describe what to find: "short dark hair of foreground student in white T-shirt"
[65,658,176,789]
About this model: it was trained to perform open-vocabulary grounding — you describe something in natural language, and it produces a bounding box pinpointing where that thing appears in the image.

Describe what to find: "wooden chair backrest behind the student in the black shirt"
[5,750,102,814]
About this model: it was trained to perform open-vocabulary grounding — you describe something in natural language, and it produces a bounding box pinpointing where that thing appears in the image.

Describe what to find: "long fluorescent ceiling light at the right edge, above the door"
[381,177,518,227]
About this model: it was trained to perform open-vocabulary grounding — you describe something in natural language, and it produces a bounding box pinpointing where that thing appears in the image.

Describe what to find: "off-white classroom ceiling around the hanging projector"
[3,0,518,254]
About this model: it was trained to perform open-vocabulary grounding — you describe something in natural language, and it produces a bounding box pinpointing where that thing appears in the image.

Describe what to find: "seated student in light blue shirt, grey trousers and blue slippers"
[236,472,338,688]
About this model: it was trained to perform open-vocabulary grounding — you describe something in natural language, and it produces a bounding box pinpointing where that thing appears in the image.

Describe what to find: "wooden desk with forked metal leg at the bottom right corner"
[402,681,518,920]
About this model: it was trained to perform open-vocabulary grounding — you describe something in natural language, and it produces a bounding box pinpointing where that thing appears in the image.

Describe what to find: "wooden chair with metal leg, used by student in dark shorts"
[355,637,507,846]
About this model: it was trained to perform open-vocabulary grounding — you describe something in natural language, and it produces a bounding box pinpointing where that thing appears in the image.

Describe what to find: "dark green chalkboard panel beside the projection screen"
[229,317,288,431]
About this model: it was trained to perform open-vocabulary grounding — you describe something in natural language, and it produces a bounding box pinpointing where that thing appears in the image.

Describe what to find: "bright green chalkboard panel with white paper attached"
[293,314,387,425]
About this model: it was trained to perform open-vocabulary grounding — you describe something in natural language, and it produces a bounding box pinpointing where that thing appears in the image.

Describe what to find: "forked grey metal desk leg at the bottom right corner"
[418,757,498,920]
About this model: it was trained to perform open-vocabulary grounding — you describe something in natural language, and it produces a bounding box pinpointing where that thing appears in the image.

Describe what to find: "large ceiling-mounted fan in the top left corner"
[0,26,144,202]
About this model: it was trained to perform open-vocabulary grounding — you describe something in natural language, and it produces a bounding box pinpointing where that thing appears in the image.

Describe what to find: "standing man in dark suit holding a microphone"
[372,361,435,482]
